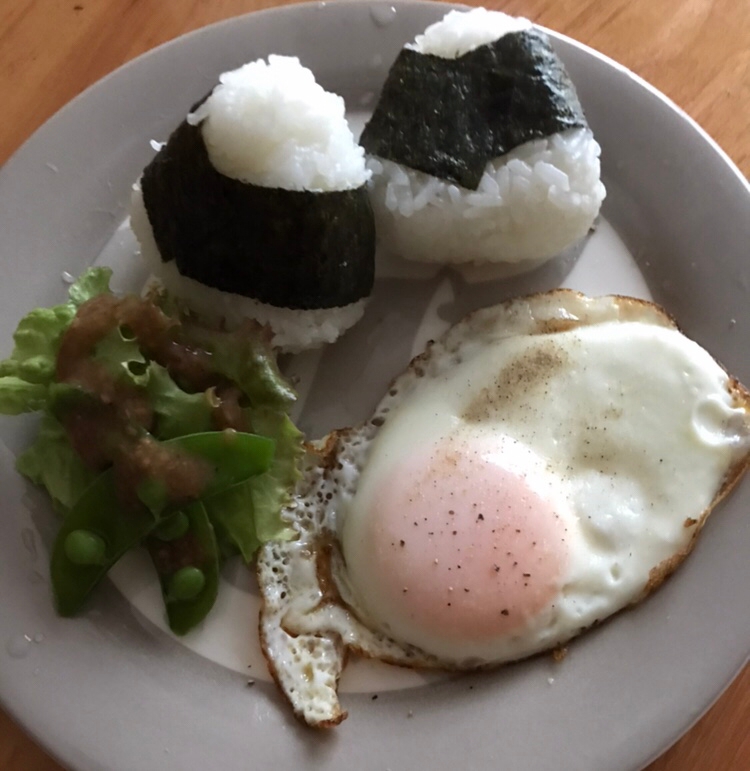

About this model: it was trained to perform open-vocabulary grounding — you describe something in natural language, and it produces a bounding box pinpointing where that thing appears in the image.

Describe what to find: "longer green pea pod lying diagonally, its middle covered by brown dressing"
[50,431,274,616]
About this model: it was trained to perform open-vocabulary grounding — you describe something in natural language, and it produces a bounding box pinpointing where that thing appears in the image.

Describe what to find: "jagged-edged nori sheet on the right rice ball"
[360,29,588,190]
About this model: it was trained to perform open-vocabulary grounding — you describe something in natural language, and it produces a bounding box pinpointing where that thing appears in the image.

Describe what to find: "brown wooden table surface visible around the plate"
[0,0,750,771]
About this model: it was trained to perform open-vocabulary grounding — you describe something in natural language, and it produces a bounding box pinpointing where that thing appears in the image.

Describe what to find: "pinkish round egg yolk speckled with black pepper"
[356,437,568,645]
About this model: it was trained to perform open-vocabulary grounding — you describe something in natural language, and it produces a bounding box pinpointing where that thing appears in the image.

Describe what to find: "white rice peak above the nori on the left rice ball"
[187,56,370,191]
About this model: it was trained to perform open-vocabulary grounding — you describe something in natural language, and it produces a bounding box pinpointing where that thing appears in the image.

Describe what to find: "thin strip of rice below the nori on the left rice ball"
[130,185,367,353]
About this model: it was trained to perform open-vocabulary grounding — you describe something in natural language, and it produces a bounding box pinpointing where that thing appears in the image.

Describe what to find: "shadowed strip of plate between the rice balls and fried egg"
[290,231,588,439]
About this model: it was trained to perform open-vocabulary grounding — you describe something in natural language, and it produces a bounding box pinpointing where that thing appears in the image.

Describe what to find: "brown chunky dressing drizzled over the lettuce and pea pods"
[56,294,249,506]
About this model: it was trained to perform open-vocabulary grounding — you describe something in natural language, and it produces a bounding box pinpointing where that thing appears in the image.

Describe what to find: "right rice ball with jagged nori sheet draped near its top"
[360,8,605,272]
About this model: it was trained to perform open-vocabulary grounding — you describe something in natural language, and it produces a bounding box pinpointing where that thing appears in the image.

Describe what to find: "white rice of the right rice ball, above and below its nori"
[367,8,606,269]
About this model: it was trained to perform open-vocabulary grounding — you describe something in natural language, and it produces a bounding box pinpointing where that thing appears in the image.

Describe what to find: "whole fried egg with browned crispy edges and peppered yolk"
[258,290,750,726]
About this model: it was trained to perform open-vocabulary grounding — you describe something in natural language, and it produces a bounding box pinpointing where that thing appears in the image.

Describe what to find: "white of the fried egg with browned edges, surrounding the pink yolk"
[258,290,750,725]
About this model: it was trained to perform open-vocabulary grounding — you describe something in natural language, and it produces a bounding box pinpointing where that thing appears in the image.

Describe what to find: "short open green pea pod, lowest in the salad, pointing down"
[146,501,219,634]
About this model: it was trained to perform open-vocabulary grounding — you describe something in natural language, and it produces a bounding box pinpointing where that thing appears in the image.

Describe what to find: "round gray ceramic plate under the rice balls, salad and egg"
[0,2,750,771]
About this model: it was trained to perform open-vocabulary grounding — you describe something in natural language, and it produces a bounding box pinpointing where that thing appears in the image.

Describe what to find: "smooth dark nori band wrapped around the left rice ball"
[141,119,375,309]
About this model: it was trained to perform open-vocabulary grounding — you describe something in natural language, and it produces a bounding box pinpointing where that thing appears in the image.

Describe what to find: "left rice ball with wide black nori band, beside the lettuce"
[131,56,375,351]
